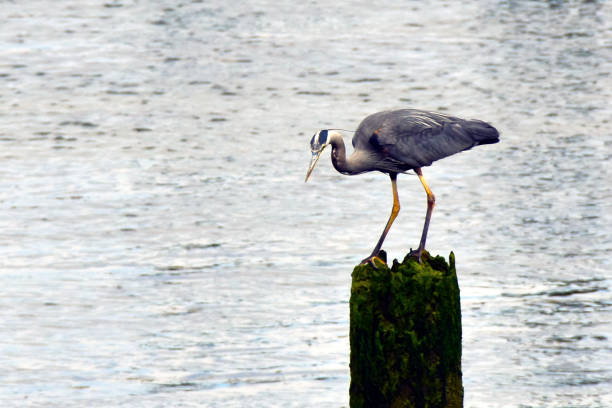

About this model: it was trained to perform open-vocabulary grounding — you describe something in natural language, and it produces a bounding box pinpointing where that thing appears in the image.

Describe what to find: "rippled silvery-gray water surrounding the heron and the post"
[0,0,612,407]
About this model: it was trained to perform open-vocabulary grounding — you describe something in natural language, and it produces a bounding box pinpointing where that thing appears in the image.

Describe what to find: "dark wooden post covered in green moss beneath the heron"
[350,252,463,408]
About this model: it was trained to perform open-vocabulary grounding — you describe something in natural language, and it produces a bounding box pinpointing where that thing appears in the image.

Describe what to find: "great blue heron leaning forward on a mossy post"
[305,109,499,266]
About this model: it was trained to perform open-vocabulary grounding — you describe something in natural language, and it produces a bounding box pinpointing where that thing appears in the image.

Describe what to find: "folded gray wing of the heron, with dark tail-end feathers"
[356,109,499,171]
